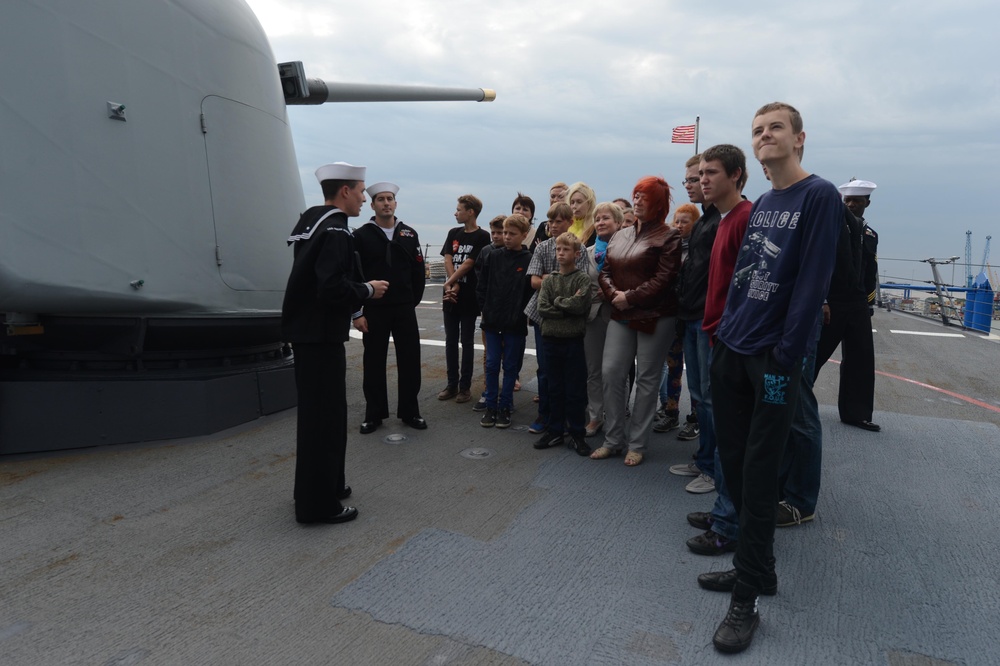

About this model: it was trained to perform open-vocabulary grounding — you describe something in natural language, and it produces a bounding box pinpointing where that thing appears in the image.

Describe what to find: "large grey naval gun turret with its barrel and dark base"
[0,0,495,454]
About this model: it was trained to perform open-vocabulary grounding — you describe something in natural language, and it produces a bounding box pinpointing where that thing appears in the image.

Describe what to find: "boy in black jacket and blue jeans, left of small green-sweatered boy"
[476,215,531,428]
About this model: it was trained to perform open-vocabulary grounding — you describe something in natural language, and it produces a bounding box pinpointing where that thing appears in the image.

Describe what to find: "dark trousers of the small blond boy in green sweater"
[542,338,587,438]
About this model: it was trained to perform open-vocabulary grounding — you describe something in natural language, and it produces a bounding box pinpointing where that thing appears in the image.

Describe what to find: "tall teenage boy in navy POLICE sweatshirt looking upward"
[711,102,843,652]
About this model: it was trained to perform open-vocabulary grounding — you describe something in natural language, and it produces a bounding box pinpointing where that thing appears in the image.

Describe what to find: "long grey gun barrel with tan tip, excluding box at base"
[285,79,497,104]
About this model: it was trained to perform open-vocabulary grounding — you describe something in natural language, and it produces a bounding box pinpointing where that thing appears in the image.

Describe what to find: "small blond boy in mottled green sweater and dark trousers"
[534,231,593,456]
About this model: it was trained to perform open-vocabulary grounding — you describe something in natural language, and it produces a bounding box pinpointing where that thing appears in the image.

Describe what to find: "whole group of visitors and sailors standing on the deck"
[283,102,878,652]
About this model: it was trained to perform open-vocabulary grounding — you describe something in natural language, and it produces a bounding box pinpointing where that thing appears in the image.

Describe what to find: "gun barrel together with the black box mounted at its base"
[278,61,497,106]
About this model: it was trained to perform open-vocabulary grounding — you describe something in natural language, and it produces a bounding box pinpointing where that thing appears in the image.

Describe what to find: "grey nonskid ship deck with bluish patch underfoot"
[0,307,1000,666]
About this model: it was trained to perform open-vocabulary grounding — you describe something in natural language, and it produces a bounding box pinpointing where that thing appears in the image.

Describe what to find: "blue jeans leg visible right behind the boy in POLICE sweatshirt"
[778,318,823,516]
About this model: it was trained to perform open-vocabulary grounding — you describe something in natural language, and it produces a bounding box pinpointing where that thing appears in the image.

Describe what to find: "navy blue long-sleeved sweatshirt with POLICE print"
[718,175,844,369]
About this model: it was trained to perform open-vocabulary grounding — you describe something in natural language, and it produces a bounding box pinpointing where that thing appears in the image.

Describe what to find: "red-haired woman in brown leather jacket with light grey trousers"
[590,176,681,466]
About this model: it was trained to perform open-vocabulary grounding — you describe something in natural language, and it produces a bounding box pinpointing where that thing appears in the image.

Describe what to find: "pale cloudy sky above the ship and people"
[248,0,1000,290]
